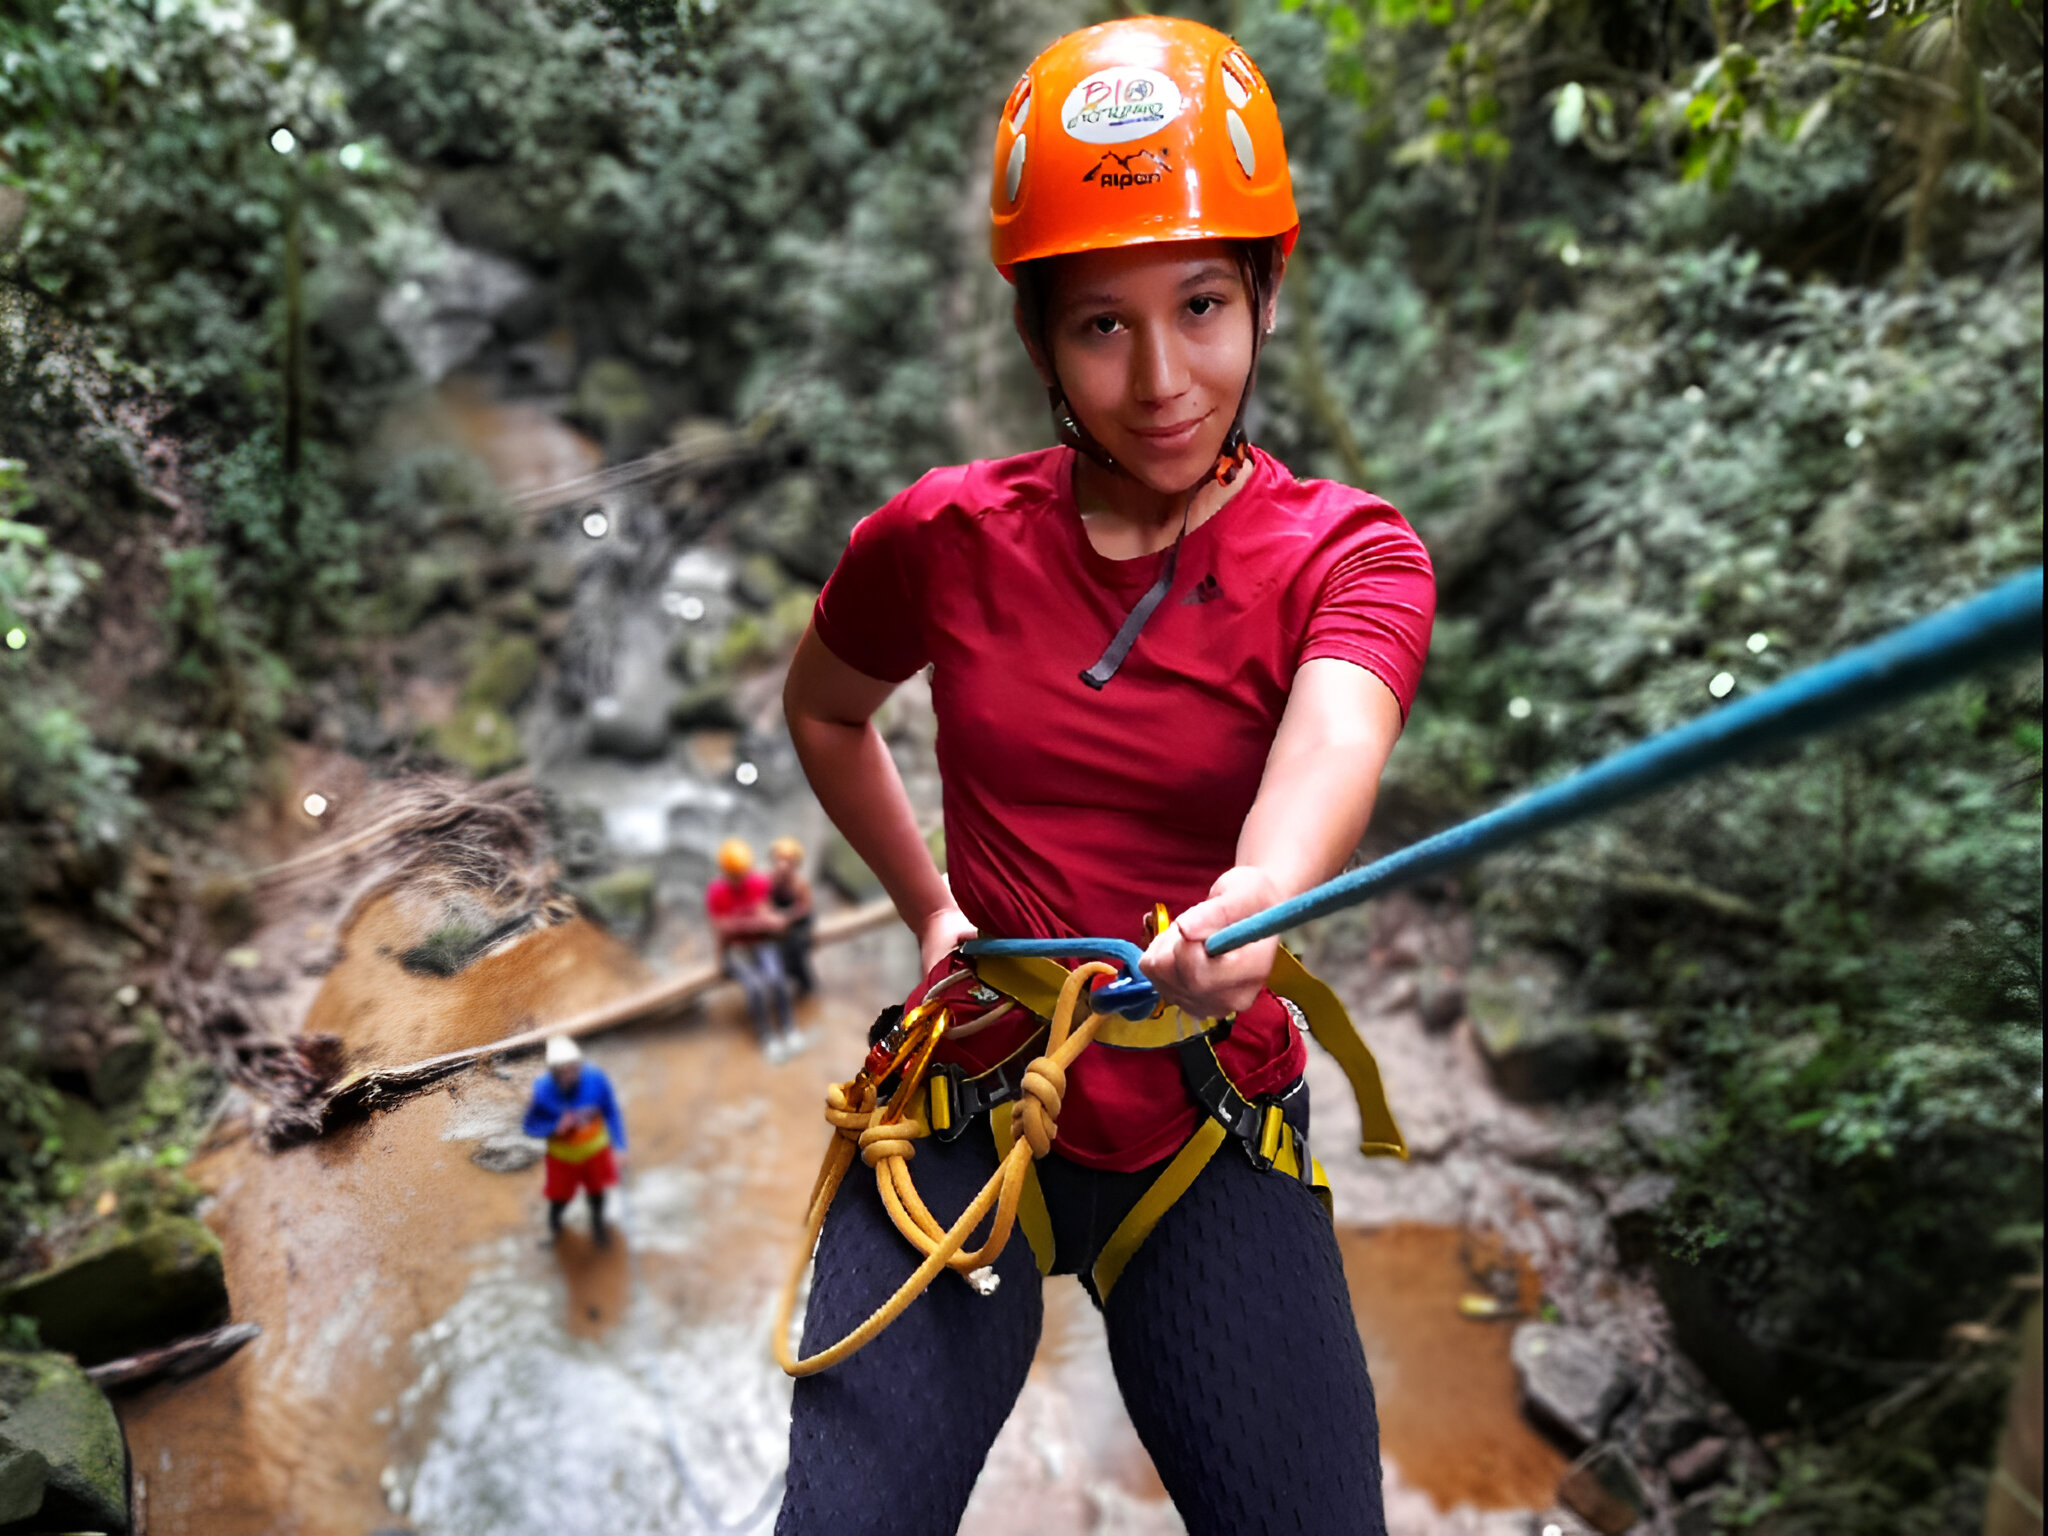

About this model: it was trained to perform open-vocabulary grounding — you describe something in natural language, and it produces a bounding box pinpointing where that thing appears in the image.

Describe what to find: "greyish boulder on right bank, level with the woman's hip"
[1464,950,1626,1104]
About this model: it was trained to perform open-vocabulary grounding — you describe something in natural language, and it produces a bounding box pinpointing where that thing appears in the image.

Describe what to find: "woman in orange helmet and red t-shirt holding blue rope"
[778,16,1436,1536]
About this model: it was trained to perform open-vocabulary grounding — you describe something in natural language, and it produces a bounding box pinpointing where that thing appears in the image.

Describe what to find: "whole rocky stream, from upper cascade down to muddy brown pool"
[121,377,1597,1536]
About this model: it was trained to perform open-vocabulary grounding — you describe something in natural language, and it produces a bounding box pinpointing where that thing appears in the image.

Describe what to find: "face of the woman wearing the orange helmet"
[1047,240,1264,494]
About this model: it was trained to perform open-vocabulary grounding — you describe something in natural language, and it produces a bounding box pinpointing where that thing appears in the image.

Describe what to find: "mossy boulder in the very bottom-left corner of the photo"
[0,1352,129,1536]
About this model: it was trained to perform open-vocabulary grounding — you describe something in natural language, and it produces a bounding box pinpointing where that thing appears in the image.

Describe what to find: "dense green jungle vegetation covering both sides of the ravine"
[0,0,2042,1532]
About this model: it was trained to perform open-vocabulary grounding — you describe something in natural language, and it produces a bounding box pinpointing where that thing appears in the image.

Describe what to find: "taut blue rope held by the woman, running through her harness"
[961,565,2042,1016]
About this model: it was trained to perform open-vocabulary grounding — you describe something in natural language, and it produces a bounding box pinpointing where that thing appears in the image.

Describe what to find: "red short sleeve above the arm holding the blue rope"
[1296,502,1436,719]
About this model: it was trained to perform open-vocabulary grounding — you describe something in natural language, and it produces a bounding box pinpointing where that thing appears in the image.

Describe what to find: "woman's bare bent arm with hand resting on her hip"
[782,629,975,969]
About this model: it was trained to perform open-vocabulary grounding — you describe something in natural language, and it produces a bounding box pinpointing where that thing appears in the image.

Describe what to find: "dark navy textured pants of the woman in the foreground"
[776,1124,1386,1536]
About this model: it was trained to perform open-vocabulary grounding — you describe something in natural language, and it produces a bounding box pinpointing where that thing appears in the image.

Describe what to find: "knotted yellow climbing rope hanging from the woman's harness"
[774,961,1116,1376]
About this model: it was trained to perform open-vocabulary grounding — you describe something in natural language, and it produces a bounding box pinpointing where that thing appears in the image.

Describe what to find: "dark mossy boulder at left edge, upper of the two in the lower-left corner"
[0,1217,227,1366]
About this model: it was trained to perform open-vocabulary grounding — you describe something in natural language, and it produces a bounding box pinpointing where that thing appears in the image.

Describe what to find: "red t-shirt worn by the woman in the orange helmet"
[815,449,1436,1169]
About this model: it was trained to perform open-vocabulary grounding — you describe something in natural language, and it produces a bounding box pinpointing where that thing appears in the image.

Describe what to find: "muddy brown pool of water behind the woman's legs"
[121,903,1563,1536]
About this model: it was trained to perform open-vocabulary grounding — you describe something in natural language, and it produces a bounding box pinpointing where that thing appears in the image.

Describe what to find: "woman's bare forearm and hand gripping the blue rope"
[1143,657,1401,1018]
